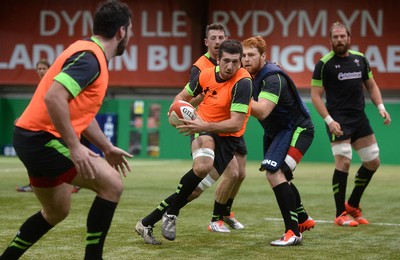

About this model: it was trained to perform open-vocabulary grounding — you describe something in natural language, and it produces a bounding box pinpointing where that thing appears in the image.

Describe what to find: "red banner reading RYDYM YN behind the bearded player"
[210,0,400,89]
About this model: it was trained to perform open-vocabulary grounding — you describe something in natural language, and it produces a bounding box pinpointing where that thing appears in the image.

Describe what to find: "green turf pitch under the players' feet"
[0,157,400,260]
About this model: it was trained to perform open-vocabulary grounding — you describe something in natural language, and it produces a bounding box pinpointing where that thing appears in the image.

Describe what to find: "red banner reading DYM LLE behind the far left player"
[0,0,193,87]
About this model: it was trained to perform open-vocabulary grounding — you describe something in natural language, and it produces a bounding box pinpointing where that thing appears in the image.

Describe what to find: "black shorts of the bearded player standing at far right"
[325,111,374,143]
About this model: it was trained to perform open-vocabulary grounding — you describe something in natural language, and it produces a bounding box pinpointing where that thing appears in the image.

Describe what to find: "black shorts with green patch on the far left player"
[13,127,76,187]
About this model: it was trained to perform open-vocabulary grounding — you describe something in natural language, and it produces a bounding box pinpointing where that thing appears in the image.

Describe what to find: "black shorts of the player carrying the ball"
[195,132,241,175]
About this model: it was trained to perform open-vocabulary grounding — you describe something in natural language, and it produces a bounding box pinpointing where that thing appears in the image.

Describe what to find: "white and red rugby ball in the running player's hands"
[168,100,196,127]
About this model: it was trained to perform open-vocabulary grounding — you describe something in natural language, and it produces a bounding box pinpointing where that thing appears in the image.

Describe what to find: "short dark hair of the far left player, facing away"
[93,0,132,39]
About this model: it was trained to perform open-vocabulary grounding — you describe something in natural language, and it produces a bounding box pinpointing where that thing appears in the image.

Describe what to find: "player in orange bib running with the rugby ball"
[136,39,252,244]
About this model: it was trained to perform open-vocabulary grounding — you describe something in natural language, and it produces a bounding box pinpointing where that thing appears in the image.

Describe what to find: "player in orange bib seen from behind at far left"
[0,1,132,259]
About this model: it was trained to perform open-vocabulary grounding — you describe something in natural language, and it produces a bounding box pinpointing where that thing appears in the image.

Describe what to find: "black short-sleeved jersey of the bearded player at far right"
[311,50,372,114]
